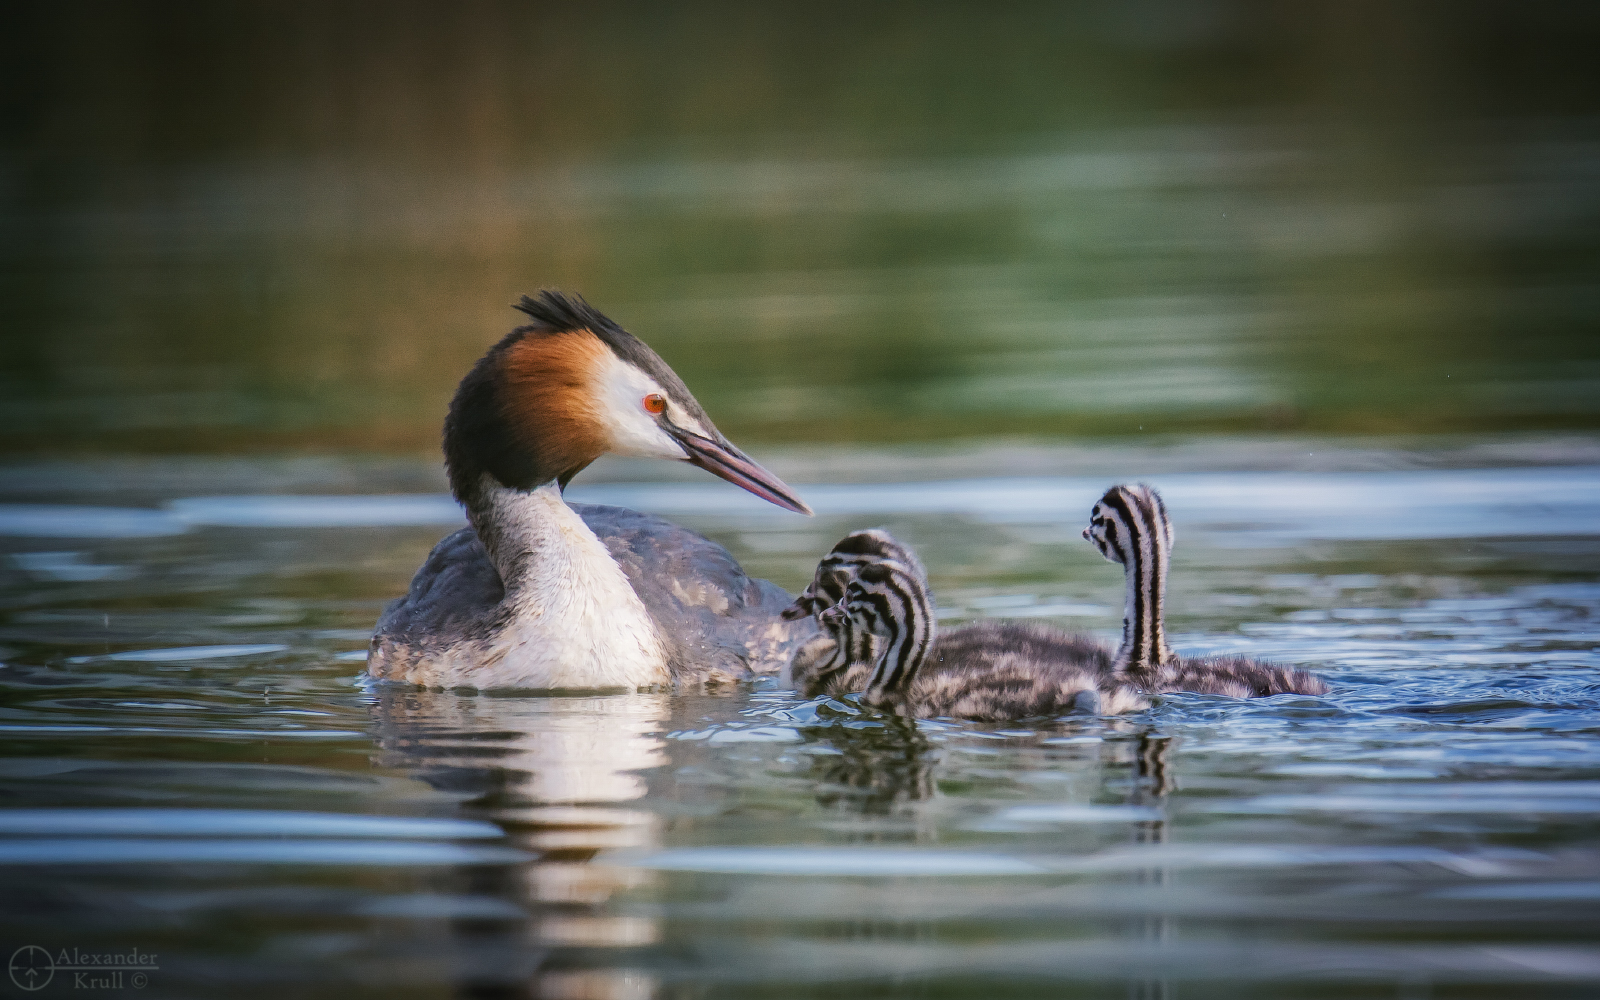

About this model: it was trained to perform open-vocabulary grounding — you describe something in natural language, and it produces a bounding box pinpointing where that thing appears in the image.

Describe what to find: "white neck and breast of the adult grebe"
[467,475,670,690]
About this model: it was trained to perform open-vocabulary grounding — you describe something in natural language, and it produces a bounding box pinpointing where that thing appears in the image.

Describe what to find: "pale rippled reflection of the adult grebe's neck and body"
[373,690,669,1000]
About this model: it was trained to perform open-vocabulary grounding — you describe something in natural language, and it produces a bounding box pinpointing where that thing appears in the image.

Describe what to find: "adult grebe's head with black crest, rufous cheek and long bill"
[445,291,811,514]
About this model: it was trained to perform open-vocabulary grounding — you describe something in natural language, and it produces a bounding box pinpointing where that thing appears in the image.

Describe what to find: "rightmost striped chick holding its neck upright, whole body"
[1083,485,1328,698]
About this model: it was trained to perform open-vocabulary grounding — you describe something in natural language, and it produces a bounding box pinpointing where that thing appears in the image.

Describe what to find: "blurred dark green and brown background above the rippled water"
[0,0,1600,453]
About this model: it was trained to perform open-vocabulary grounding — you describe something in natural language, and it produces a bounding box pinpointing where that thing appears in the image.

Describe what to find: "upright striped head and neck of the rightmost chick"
[1083,485,1176,670]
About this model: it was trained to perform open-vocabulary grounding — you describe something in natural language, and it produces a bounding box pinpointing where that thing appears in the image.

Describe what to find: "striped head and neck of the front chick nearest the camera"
[822,562,936,706]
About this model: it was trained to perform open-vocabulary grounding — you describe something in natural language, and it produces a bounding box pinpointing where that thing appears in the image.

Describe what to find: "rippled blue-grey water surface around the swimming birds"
[0,446,1600,997]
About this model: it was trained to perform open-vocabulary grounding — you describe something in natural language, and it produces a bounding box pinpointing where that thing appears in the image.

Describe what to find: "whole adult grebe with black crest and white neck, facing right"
[366,291,814,690]
